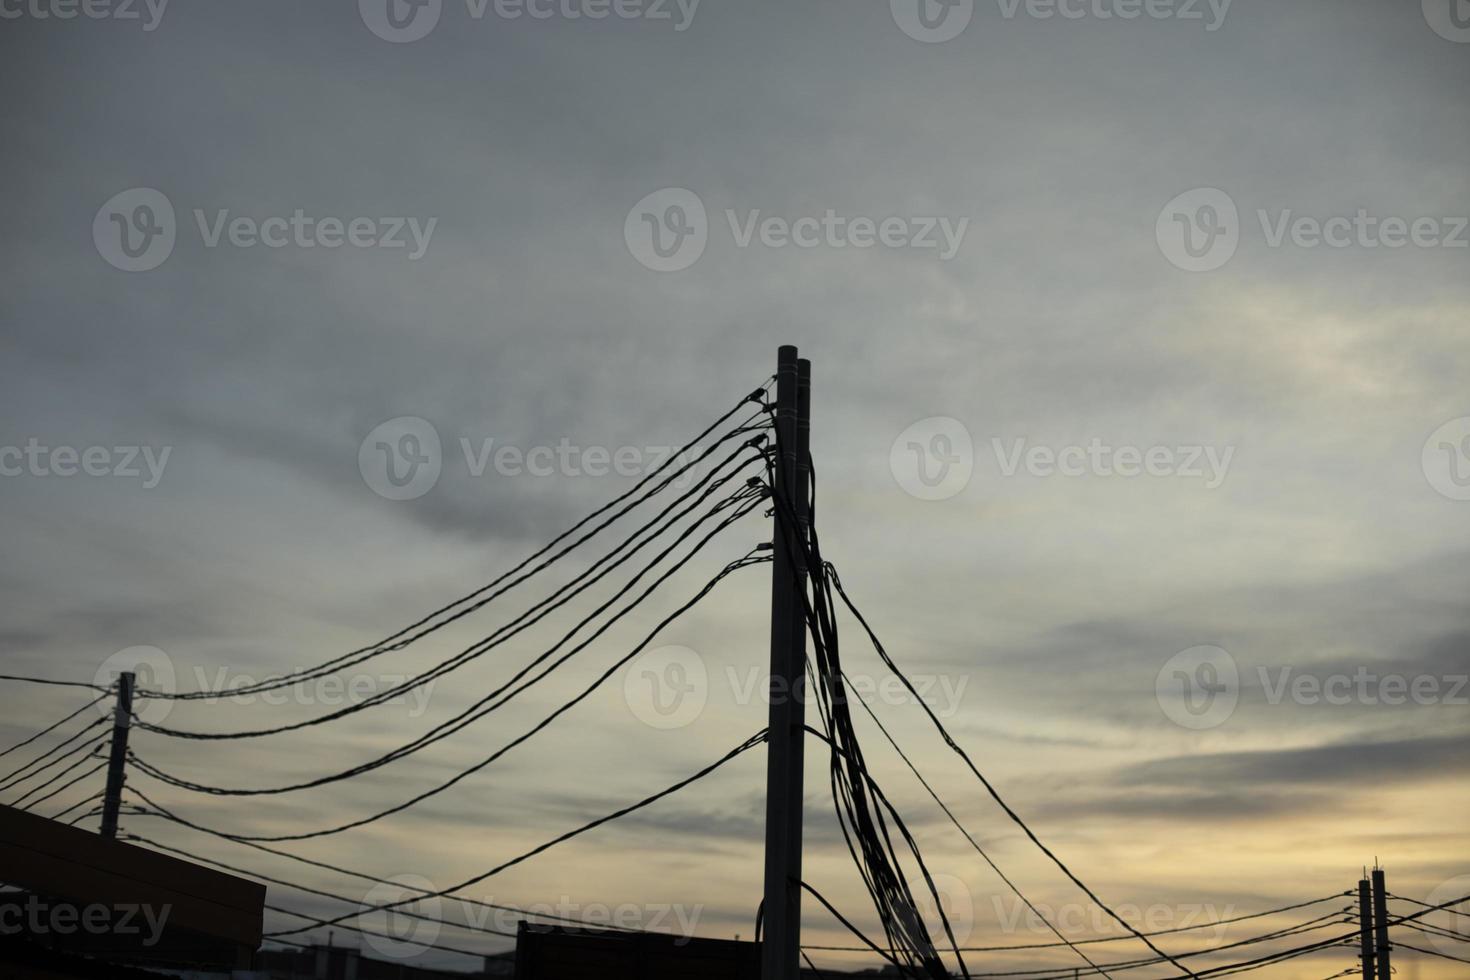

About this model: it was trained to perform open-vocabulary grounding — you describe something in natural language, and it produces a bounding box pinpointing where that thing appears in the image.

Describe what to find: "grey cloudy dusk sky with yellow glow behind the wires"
[0,0,1470,980]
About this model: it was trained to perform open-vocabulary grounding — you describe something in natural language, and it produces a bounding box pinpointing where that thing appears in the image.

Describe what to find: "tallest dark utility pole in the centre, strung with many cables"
[760,345,811,980]
